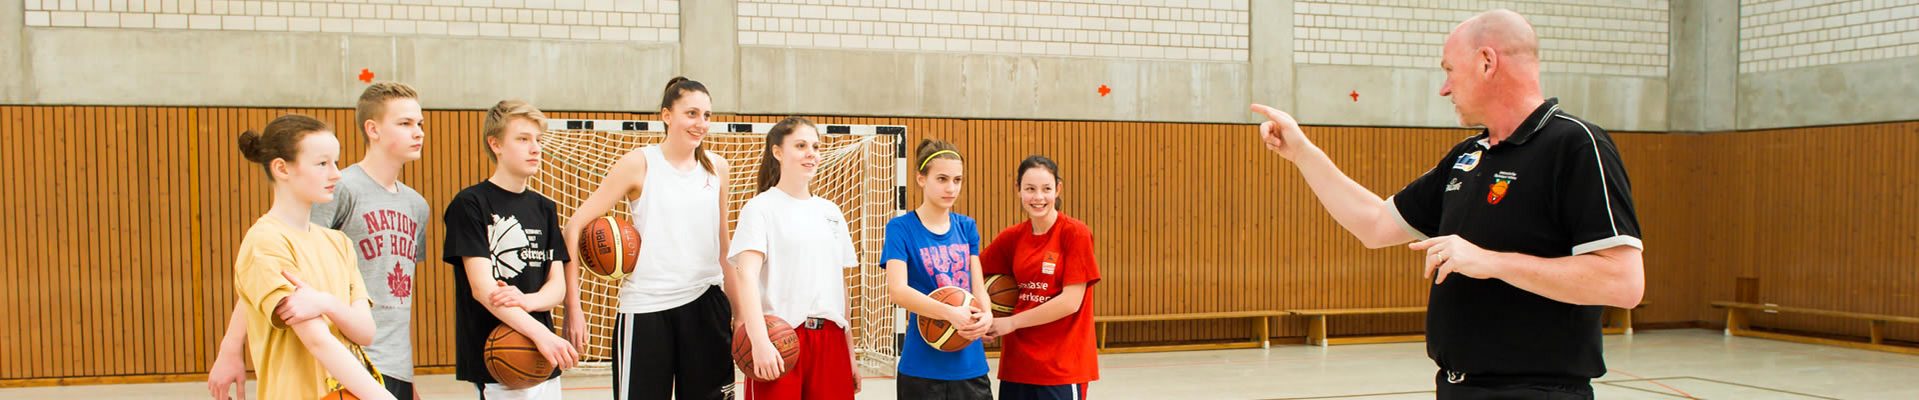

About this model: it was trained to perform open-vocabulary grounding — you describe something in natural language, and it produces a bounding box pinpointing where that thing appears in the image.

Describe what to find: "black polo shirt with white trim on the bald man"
[1387,98,1643,381]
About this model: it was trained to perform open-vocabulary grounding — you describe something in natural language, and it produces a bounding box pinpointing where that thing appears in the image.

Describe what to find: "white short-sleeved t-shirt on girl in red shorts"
[727,188,860,327]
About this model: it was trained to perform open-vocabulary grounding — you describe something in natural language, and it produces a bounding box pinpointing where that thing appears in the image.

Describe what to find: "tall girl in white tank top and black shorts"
[566,77,735,400]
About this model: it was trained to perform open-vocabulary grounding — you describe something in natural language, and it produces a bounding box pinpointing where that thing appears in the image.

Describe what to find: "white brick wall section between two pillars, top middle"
[739,0,1251,62]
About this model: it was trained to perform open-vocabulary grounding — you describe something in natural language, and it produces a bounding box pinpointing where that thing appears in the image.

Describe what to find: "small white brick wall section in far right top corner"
[1742,0,1919,73]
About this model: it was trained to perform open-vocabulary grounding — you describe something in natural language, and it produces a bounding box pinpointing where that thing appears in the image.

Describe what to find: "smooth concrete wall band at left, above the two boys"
[14,29,679,112]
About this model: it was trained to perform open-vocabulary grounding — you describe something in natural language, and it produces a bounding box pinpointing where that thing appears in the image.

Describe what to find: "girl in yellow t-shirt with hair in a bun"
[215,113,393,400]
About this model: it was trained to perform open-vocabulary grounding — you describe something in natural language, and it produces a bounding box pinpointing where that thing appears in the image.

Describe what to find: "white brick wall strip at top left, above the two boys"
[25,0,679,42]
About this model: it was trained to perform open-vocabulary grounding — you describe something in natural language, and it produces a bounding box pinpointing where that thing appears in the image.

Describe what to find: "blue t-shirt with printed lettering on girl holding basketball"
[881,212,986,381]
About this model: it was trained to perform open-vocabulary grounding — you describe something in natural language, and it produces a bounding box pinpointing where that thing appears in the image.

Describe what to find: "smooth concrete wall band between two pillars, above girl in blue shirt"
[739,46,1249,123]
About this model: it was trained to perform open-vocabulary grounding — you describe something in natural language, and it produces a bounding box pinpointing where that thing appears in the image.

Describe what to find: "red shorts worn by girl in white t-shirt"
[746,321,854,400]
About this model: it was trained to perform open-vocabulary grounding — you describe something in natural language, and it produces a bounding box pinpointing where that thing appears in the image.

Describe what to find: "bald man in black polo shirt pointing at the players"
[1253,10,1645,398]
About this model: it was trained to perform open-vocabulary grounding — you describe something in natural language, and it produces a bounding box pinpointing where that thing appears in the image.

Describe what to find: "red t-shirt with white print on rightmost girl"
[981,213,1100,385]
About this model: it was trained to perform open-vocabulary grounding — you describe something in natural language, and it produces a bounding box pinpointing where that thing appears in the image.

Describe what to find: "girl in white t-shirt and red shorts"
[727,117,860,400]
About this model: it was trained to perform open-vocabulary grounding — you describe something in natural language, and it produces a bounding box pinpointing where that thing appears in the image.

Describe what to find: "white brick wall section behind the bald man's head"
[1293,0,1673,77]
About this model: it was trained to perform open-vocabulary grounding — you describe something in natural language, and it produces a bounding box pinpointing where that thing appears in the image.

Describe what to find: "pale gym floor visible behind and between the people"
[0,329,1919,400]
